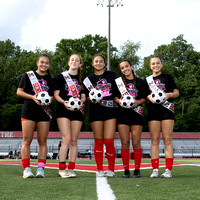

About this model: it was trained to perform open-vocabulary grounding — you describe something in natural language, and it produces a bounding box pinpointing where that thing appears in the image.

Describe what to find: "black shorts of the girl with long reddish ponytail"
[57,105,83,121]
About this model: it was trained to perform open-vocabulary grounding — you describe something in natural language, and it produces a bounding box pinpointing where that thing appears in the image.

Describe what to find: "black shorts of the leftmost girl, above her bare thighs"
[21,110,51,122]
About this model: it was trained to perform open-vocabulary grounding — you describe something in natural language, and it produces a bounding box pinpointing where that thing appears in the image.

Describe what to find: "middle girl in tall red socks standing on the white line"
[83,54,116,177]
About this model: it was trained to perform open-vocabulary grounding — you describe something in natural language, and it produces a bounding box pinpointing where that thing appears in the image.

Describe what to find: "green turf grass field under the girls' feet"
[0,159,200,200]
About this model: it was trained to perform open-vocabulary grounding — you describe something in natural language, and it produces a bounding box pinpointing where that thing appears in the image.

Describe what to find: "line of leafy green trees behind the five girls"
[0,35,200,132]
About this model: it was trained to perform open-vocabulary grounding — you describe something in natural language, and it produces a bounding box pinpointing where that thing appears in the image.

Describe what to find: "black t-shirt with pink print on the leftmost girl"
[18,71,54,113]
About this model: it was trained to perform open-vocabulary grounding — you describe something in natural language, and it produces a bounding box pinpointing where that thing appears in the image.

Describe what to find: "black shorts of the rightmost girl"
[147,105,175,121]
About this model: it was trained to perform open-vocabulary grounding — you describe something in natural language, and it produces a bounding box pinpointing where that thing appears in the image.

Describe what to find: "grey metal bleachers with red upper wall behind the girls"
[0,132,200,158]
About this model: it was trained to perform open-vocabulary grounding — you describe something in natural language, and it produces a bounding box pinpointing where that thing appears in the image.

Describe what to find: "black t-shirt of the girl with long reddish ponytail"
[55,74,83,100]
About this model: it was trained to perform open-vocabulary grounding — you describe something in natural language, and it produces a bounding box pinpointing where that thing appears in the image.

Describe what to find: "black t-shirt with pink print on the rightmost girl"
[145,73,178,108]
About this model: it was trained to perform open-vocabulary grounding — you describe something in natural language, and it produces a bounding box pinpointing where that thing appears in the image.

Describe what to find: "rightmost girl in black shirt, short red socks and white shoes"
[146,56,179,178]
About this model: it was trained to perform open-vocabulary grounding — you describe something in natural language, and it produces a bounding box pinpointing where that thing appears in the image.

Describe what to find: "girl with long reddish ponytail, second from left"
[54,54,85,178]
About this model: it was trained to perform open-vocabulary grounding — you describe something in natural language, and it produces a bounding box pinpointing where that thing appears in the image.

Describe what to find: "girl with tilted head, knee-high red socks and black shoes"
[115,60,146,178]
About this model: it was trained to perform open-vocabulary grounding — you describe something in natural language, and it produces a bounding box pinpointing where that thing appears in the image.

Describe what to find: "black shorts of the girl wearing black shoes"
[117,108,144,126]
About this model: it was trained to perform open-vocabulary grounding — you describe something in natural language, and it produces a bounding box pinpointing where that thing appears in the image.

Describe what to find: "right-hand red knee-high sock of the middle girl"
[104,139,115,172]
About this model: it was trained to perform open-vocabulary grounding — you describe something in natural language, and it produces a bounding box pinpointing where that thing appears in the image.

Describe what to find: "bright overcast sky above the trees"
[0,0,200,58]
